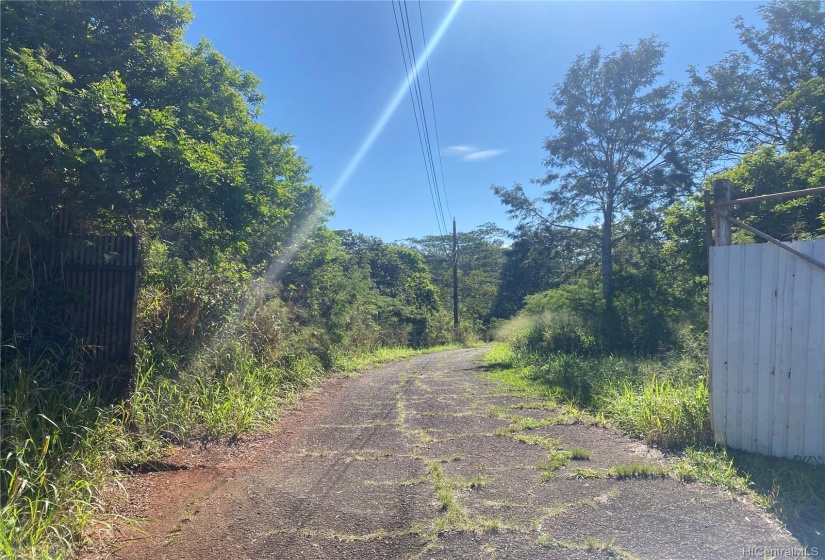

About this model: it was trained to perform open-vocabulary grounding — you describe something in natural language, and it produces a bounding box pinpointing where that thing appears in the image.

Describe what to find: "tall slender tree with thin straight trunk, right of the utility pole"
[493,37,692,336]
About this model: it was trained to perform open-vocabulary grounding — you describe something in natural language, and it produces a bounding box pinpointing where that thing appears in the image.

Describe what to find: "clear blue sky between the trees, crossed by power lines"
[186,0,760,241]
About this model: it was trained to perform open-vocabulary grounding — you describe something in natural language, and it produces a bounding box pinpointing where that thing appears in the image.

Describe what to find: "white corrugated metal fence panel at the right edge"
[709,240,825,463]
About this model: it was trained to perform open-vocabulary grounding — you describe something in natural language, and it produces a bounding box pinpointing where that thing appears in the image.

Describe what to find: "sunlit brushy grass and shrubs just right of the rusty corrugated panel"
[129,292,325,443]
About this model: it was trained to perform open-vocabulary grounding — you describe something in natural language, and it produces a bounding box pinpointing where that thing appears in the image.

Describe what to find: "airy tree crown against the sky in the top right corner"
[688,0,825,156]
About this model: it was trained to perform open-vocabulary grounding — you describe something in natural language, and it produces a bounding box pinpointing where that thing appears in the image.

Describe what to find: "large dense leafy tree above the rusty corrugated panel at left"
[0,0,322,350]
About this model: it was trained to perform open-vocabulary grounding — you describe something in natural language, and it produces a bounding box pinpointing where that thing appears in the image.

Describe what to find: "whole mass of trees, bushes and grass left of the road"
[0,1,460,557]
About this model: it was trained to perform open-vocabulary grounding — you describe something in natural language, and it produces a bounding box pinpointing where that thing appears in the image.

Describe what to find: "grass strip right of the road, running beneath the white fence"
[486,336,825,550]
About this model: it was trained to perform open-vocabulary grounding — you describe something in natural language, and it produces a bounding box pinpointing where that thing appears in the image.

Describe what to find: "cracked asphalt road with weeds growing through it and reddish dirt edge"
[81,349,799,560]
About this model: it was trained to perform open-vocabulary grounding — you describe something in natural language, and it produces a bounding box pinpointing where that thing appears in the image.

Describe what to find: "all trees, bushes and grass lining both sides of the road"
[0,0,825,558]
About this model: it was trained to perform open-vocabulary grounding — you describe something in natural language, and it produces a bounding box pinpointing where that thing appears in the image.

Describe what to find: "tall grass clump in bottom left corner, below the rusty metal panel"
[0,348,128,558]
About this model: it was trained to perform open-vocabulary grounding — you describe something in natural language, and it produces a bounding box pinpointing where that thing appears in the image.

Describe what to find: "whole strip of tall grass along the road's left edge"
[0,299,464,558]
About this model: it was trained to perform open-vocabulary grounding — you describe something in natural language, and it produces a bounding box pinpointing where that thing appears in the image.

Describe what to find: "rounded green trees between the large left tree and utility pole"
[282,229,452,349]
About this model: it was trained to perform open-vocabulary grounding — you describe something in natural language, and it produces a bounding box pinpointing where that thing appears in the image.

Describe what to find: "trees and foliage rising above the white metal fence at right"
[686,0,825,243]
